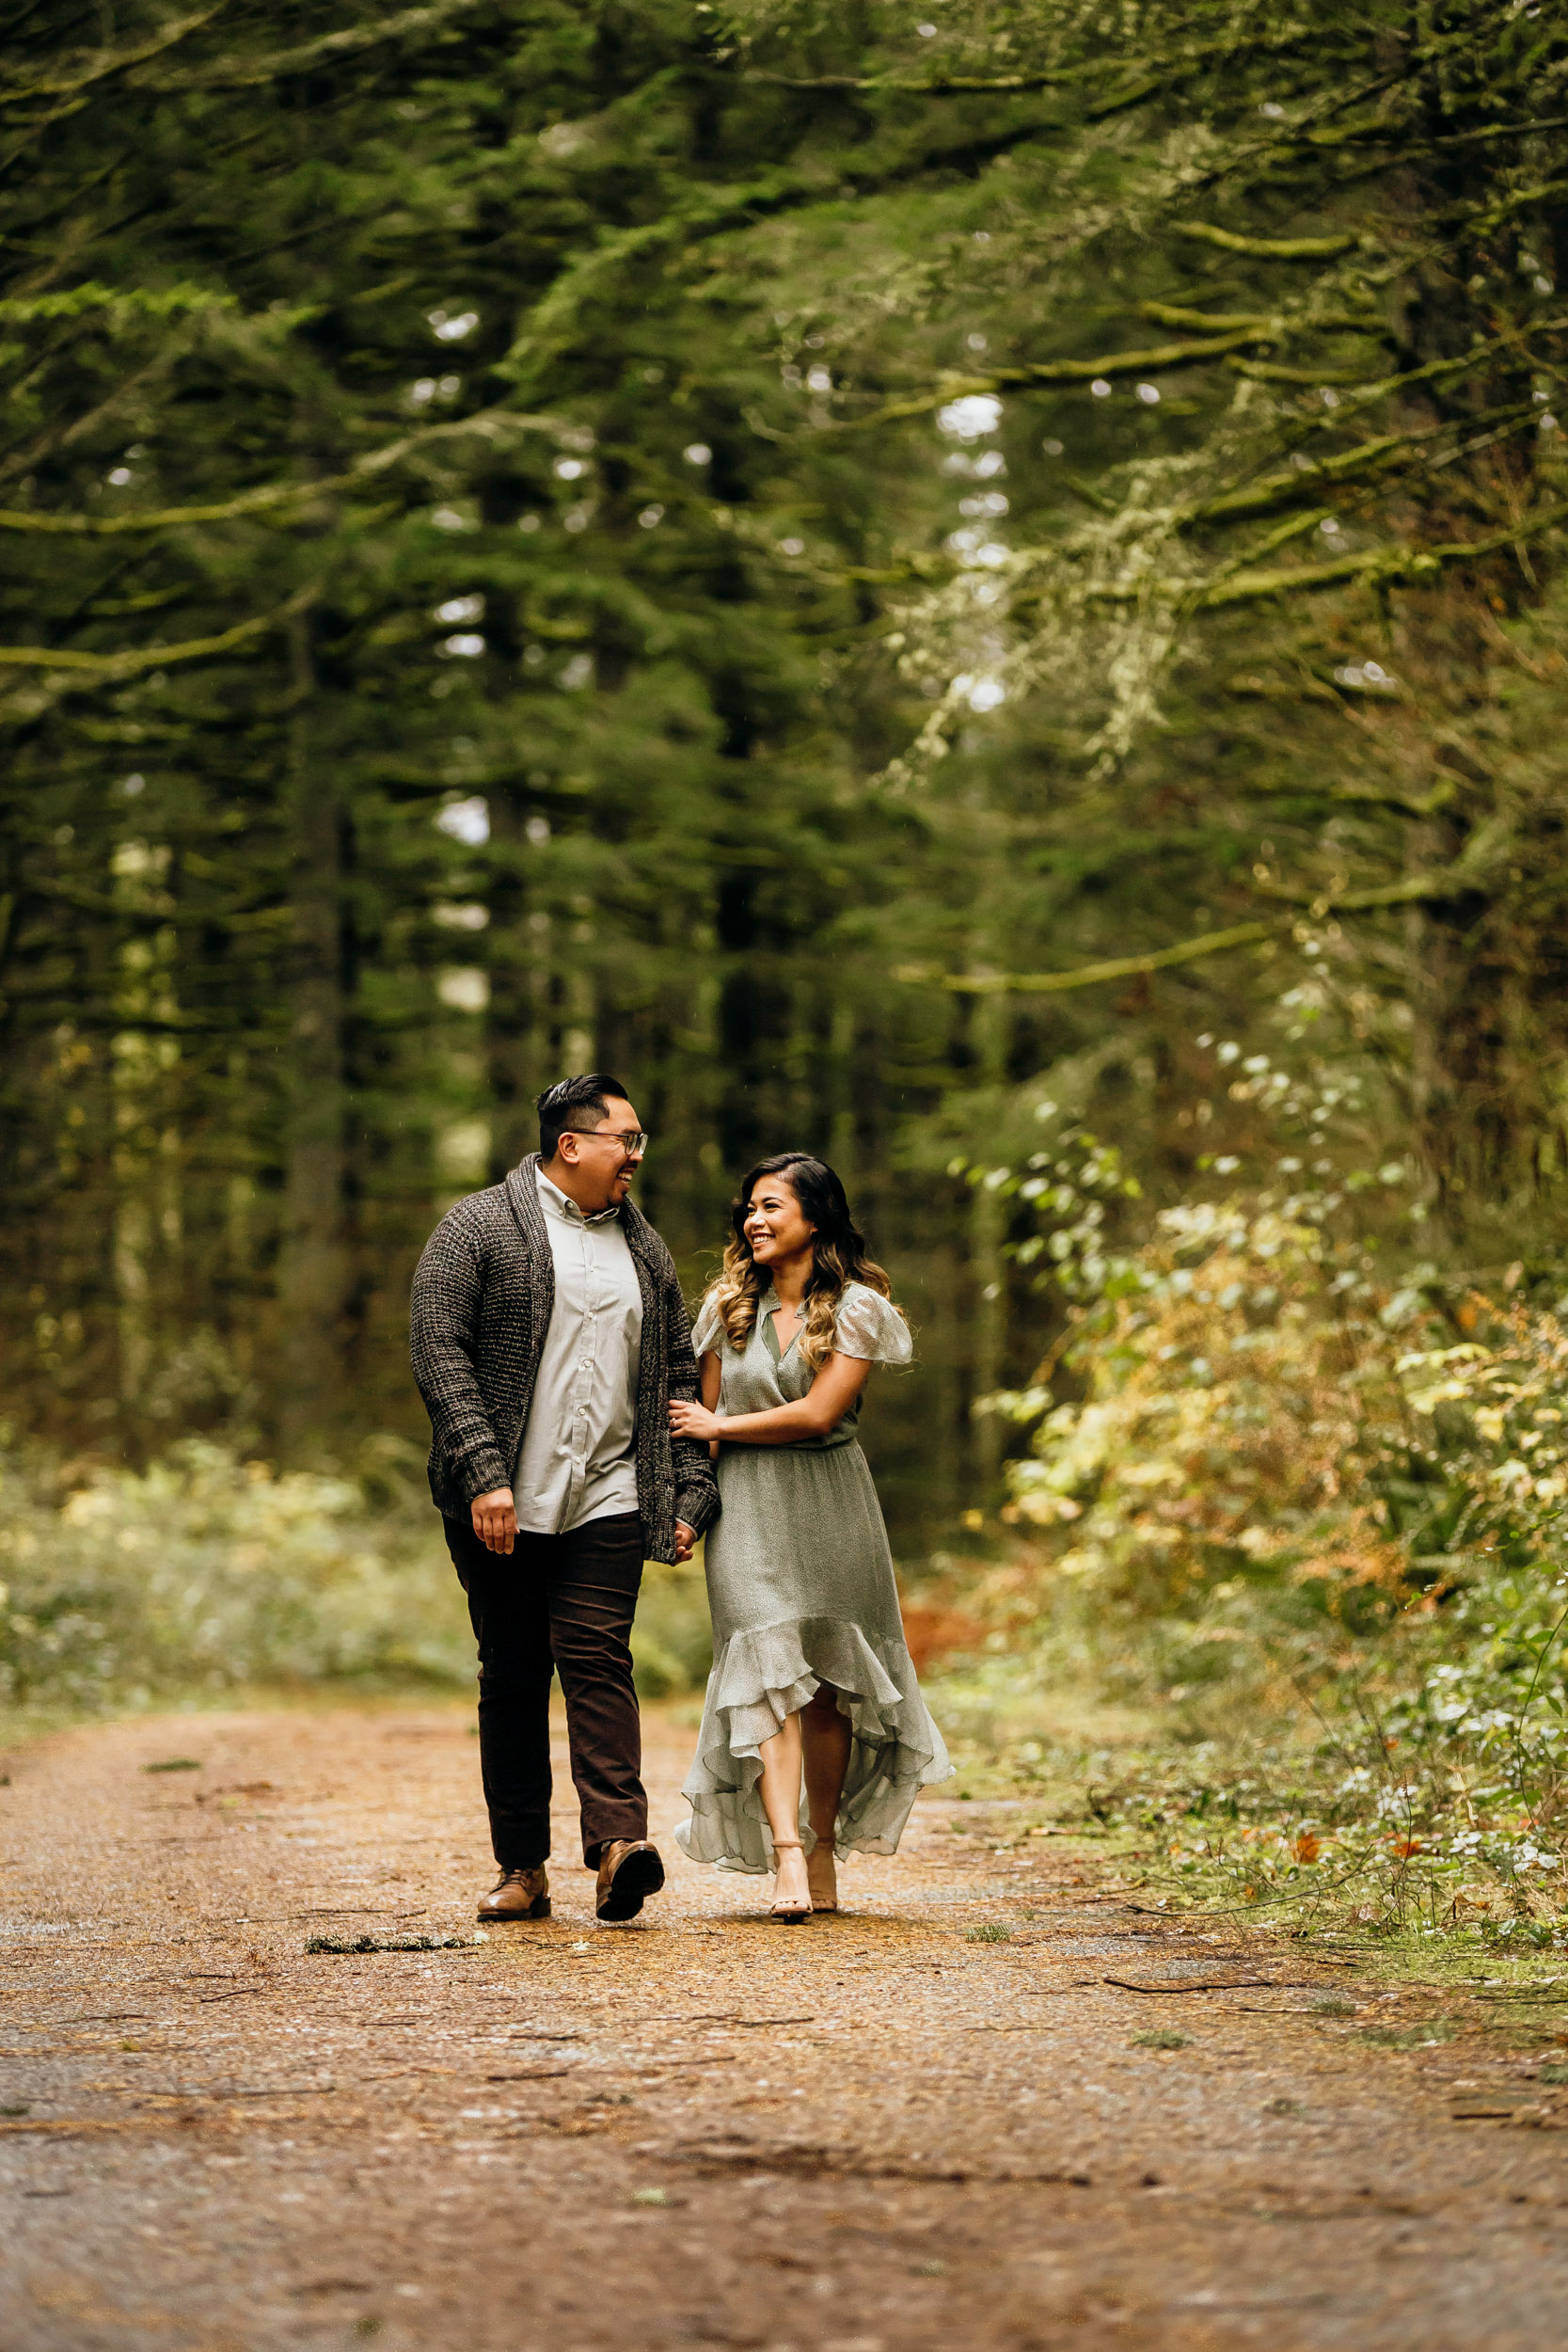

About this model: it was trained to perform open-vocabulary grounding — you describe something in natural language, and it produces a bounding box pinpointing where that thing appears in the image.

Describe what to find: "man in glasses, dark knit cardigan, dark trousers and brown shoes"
[411,1071,720,1919]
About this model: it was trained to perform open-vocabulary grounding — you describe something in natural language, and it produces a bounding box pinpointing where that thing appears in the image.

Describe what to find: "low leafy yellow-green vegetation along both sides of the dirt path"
[0,981,1568,1952]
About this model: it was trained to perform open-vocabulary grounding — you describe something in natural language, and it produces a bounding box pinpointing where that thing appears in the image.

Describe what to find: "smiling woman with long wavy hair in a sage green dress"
[670,1152,952,1922]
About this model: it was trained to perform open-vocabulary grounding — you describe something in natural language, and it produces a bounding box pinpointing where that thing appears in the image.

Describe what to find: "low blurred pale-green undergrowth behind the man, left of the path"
[0,1439,707,1708]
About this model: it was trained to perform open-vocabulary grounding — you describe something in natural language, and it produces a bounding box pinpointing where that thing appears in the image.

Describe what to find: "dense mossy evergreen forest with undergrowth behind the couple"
[0,0,1568,1919]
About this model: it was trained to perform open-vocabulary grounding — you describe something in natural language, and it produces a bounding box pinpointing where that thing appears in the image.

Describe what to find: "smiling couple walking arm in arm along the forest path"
[411,1073,950,1922]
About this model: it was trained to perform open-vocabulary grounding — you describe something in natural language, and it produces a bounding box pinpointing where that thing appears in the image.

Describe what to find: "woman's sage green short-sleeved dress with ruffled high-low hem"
[674,1282,952,1872]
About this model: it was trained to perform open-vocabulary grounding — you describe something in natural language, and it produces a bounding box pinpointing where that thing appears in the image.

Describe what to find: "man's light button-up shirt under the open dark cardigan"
[513,1169,641,1536]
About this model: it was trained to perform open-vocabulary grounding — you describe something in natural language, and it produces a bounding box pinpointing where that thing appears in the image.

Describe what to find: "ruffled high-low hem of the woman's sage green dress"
[674,1616,952,1875]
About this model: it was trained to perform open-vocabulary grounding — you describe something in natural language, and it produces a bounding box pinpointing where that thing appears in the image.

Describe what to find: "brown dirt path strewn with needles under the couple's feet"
[0,1708,1568,2352]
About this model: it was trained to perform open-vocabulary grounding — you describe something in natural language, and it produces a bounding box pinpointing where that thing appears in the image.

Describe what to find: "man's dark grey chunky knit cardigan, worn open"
[409,1152,720,1562]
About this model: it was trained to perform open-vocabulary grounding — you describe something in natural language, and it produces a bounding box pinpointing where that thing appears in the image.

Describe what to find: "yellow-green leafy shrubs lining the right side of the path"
[933,1057,1568,1946]
